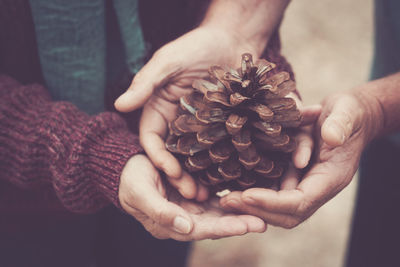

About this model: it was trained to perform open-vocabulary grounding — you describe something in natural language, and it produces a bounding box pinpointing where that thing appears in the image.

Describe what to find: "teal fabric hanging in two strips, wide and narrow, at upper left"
[30,0,146,114]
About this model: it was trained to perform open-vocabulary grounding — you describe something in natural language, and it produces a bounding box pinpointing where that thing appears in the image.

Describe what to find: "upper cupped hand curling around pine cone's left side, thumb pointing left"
[115,26,259,198]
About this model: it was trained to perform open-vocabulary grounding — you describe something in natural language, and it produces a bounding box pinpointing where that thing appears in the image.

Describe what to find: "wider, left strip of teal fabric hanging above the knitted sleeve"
[30,0,106,114]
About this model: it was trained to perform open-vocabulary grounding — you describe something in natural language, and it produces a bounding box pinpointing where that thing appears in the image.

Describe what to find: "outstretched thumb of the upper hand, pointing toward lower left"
[114,54,172,112]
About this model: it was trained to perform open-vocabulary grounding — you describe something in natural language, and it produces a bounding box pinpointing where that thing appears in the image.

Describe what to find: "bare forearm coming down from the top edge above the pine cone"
[201,0,290,55]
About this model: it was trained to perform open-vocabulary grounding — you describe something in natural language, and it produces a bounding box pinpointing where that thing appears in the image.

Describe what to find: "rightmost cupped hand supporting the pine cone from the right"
[220,91,382,228]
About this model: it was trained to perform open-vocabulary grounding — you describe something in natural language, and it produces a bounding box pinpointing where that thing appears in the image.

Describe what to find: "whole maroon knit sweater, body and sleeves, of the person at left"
[0,0,293,232]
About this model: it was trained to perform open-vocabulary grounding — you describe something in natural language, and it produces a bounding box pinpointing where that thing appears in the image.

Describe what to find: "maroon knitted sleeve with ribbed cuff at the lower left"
[0,75,141,213]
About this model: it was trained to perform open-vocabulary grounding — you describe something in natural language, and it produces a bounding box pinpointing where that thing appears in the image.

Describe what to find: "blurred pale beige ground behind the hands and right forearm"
[189,0,373,267]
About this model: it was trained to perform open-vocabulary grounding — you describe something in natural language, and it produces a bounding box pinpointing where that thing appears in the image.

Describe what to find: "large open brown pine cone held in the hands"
[166,53,301,191]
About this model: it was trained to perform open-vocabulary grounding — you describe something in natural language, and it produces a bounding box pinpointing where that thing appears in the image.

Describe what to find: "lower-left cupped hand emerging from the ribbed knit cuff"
[119,155,266,241]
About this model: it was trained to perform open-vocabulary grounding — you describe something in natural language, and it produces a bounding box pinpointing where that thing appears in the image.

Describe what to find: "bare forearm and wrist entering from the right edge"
[355,72,400,137]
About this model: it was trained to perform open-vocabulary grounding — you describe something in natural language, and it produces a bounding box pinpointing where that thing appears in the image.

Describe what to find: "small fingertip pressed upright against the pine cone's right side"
[292,127,314,169]
